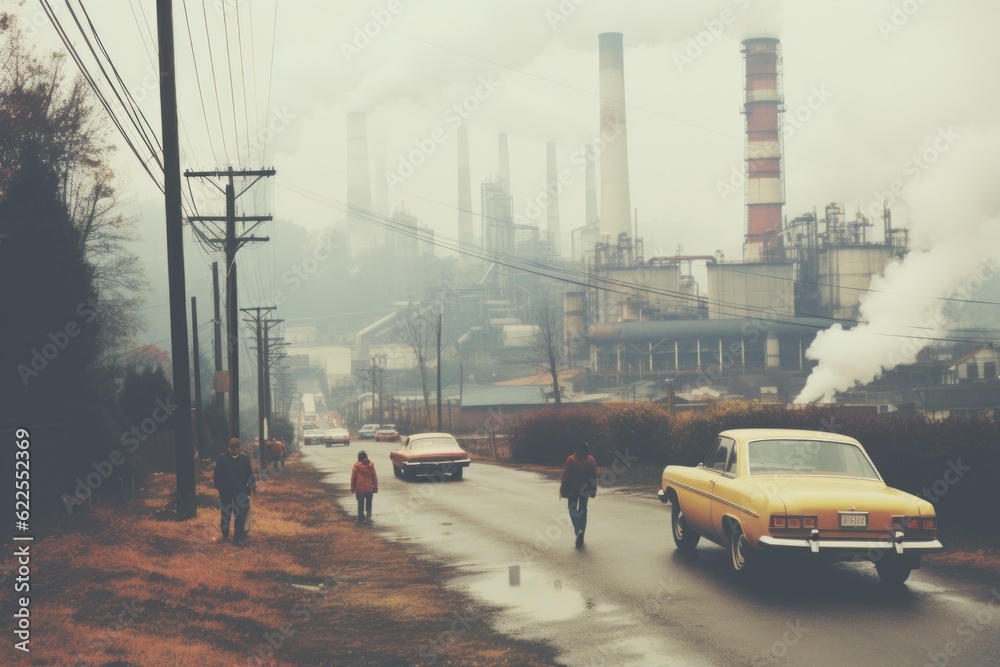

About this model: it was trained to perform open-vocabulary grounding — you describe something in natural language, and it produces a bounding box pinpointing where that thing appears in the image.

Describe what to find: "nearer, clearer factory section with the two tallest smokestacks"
[564,34,907,399]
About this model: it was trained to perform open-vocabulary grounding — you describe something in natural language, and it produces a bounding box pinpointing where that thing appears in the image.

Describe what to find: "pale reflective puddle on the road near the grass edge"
[463,566,587,623]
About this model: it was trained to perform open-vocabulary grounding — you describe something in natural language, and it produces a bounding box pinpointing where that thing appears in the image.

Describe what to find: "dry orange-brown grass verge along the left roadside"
[0,458,552,667]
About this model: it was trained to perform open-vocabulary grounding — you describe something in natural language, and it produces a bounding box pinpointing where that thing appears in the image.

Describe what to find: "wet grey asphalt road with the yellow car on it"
[305,441,1000,667]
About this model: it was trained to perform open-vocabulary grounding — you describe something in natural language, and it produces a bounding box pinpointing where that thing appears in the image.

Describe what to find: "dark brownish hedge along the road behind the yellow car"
[508,401,1000,540]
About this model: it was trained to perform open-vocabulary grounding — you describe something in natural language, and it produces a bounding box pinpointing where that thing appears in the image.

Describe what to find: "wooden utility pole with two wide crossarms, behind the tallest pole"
[184,167,276,438]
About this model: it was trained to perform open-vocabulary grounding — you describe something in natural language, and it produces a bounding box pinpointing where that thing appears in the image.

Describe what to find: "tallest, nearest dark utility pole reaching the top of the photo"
[156,0,197,517]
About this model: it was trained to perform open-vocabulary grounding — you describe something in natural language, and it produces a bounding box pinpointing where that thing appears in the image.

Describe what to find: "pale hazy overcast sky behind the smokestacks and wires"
[9,0,1000,354]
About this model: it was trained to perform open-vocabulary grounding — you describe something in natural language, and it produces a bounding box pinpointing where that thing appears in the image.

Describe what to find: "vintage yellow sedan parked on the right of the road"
[658,429,944,584]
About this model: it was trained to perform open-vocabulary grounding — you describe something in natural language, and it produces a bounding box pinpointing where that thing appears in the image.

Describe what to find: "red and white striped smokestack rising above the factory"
[742,37,785,262]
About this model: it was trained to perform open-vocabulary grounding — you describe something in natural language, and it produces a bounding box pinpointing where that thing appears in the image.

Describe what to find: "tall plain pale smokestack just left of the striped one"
[597,32,632,243]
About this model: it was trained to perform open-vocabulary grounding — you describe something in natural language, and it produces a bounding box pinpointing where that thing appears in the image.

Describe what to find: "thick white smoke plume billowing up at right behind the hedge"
[795,127,1000,403]
